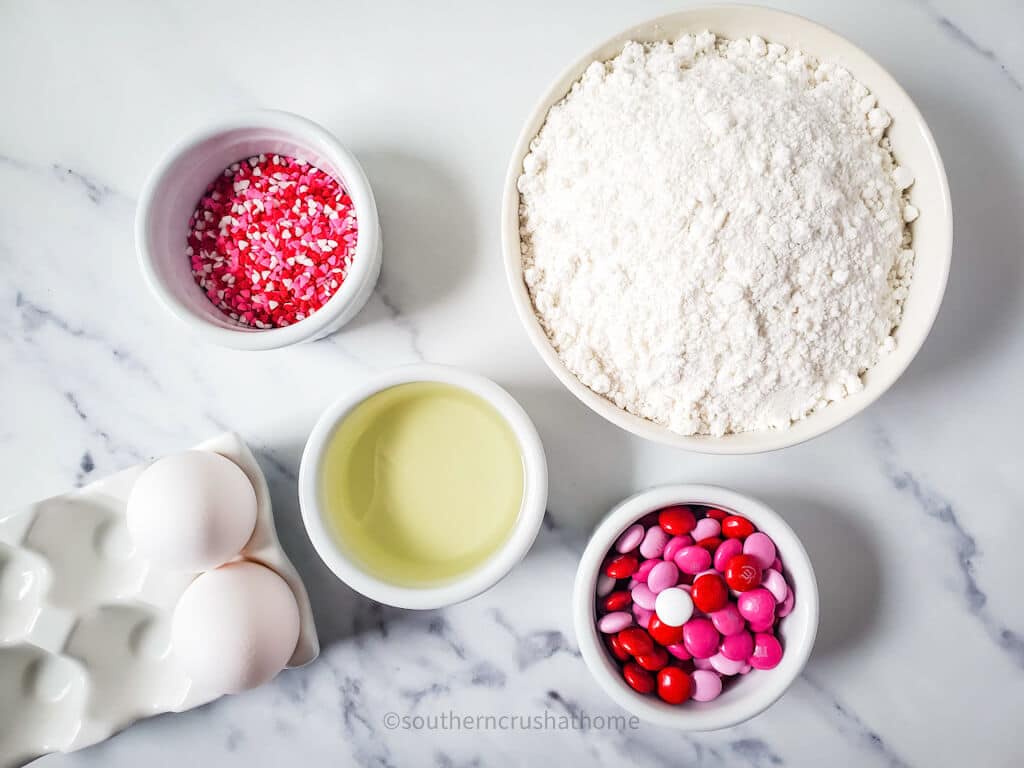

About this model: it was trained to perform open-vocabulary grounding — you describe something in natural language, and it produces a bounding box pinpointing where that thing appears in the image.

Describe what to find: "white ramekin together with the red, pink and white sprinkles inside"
[135,111,381,350]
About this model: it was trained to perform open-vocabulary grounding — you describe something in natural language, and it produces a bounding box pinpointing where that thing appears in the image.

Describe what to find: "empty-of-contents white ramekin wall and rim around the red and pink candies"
[572,485,818,731]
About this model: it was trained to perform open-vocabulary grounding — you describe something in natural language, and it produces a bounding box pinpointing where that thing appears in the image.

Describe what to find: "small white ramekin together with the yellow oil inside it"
[299,365,548,609]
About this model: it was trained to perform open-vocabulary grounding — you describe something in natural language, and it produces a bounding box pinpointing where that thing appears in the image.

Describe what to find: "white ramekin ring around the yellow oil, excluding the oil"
[299,365,548,609]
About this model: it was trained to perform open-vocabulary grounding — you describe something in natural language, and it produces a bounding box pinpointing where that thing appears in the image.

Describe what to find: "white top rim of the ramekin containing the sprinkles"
[135,110,380,350]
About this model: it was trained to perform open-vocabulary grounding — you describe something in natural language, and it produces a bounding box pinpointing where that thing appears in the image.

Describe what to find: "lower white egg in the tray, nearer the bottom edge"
[171,560,299,695]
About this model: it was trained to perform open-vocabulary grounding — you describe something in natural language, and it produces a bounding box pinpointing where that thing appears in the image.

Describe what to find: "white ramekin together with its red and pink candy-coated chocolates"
[572,485,818,731]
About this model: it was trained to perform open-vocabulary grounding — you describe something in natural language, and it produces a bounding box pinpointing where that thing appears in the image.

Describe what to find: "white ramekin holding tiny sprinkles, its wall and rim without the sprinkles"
[135,110,381,350]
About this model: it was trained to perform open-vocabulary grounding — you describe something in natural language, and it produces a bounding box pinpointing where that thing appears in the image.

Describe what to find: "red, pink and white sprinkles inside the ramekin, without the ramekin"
[185,155,358,329]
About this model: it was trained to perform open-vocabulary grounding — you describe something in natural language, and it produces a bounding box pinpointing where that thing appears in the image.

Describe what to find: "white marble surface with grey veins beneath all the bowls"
[0,0,1024,768]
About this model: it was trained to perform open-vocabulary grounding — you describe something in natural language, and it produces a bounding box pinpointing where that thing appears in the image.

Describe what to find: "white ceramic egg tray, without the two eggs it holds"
[0,434,319,768]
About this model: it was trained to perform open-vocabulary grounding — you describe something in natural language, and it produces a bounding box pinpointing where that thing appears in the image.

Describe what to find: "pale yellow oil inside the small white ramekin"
[322,382,523,587]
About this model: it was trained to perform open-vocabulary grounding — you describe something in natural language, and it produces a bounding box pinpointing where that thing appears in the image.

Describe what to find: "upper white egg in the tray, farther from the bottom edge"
[127,451,256,570]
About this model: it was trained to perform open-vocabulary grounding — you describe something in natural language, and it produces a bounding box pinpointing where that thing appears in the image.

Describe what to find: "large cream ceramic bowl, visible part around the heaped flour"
[502,5,952,454]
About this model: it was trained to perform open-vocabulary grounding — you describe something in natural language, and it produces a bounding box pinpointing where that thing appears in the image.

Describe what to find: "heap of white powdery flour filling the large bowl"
[519,33,916,435]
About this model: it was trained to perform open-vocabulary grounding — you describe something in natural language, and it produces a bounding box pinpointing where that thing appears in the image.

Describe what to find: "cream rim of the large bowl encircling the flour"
[501,5,952,455]
